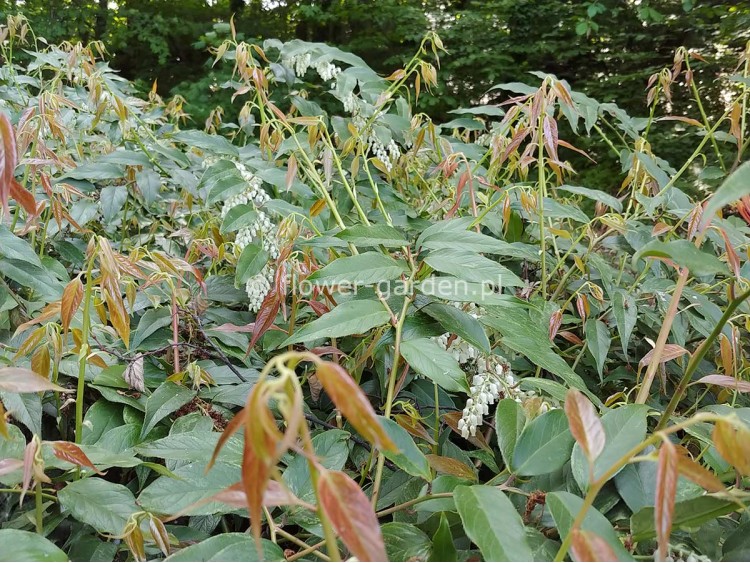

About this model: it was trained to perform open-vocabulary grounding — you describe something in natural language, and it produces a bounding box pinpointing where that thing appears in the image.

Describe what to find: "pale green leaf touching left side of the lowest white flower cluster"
[401,338,469,392]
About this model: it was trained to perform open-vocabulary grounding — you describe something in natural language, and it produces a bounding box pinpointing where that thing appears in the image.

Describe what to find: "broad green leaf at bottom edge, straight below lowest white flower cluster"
[454,485,533,561]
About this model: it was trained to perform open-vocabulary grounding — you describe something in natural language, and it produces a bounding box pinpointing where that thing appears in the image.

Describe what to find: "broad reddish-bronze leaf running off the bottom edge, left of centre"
[318,470,388,561]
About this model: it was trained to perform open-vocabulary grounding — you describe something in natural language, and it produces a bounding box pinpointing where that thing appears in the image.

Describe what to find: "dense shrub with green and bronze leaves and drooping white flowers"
[0,14,750,561]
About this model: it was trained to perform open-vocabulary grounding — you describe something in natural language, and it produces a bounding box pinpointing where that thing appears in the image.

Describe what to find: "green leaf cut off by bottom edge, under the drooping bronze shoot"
[165,533,284,562]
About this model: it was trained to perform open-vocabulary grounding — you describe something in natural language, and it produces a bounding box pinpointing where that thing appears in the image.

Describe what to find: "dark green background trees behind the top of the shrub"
[0,0,750,191]
